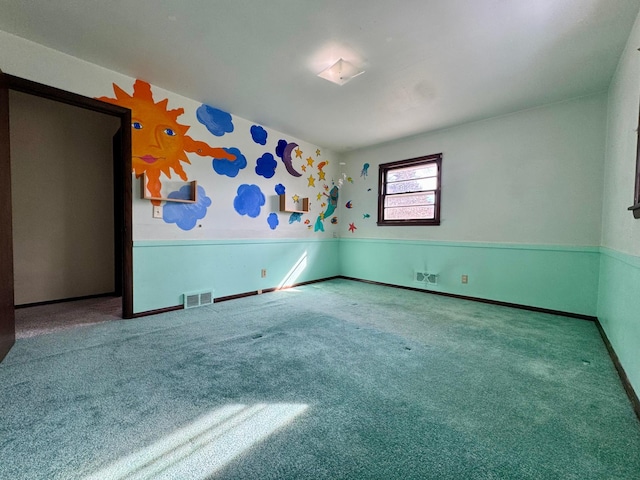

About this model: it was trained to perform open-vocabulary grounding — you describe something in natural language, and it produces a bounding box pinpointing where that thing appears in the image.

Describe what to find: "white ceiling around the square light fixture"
[0,0,640,152]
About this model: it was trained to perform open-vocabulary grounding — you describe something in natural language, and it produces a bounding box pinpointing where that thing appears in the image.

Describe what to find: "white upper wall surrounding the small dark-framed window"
[341,93,608,246]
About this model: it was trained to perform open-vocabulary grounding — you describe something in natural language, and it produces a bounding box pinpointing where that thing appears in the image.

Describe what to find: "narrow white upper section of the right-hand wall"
[602,10,640,256]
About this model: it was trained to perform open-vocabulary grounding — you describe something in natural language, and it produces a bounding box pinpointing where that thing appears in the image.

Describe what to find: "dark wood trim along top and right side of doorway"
[4,74,133,318]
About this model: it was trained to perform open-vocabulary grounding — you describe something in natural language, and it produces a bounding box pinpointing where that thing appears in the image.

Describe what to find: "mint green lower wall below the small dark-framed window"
[340,238,600,316]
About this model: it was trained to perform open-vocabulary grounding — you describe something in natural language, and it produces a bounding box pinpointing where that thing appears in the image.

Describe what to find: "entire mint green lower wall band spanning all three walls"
[133,238,640,398]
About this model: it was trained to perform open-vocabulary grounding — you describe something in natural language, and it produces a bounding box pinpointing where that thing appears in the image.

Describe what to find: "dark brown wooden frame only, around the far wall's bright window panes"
[378,153,442,226]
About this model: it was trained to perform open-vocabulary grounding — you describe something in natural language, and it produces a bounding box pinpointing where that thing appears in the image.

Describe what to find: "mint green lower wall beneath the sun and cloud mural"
[133,239,339,313]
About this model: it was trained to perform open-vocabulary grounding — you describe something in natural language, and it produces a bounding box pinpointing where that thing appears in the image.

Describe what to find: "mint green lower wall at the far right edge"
[598,248,640,396]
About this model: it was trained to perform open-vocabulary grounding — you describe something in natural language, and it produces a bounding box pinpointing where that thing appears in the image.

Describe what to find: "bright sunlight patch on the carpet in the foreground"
[85,403,308,480]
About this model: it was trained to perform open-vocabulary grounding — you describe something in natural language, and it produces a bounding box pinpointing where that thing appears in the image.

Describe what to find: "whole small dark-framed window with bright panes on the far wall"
[378,153,442,225]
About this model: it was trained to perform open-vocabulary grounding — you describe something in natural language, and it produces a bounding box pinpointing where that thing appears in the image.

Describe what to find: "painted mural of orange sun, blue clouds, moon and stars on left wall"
[99,79,342,237]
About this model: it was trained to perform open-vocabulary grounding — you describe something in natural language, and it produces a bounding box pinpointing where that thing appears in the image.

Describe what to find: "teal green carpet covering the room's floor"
[0,280,640,480]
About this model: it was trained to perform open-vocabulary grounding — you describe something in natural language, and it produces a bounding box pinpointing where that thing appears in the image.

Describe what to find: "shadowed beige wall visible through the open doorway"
[9,91,122,308]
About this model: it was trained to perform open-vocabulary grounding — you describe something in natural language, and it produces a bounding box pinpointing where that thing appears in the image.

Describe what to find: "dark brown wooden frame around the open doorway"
[0,74,133,318]
